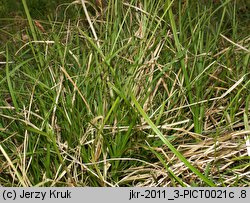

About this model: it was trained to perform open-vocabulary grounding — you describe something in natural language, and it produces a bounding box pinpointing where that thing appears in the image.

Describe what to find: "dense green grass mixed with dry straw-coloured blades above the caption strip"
[0,0,250,186]
